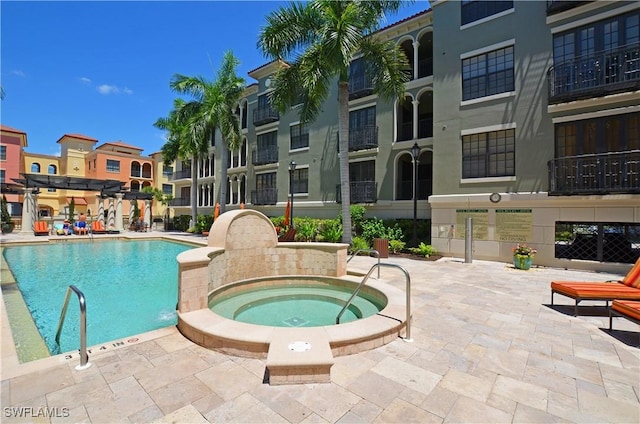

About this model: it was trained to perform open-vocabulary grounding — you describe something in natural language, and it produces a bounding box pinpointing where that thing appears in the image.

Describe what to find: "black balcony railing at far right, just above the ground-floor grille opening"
[548,150,640,196]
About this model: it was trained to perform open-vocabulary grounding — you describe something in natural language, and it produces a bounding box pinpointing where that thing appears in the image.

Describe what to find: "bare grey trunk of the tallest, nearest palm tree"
[338,81,351,244]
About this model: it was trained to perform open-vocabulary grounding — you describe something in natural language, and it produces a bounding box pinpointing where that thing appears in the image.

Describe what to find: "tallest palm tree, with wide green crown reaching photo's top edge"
[258,0,409,243]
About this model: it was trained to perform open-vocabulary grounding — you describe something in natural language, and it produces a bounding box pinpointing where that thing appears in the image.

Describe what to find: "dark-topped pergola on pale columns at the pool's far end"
[13,173,153,232]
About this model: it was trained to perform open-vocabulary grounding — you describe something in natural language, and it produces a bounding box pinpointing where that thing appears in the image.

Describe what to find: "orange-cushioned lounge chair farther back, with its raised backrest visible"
[551,258,640,316]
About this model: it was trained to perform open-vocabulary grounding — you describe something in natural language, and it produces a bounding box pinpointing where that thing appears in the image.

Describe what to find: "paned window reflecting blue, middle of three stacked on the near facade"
[462,46,515,100]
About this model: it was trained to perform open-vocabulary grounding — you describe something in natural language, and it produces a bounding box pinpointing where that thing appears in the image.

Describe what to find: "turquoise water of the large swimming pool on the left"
[4,240,193,354]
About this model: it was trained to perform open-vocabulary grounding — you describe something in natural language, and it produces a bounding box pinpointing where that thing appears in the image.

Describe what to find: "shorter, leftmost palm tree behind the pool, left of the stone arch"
[154,99,208,224]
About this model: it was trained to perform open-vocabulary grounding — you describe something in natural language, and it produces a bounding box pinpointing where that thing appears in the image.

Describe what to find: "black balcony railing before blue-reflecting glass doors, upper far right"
[547,43,640,104]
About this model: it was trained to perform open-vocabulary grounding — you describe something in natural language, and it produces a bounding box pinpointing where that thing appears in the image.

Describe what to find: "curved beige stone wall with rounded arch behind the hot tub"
[178,209,348,313]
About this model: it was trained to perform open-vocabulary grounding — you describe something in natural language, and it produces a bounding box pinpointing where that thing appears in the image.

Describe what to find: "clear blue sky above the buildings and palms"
[0,0,429,155]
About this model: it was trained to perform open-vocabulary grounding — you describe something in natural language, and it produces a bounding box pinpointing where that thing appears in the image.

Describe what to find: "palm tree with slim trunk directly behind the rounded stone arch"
[171,51,245,215]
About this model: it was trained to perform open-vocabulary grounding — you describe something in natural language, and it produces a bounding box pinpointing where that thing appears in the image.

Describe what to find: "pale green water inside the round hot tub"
[209,283,384,327]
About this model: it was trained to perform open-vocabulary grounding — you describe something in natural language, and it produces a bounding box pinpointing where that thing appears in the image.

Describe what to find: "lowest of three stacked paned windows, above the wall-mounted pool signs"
[462,129,516,178]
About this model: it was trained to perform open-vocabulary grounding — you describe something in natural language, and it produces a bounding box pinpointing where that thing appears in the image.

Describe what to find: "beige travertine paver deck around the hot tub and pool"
[1,234,640,423]
